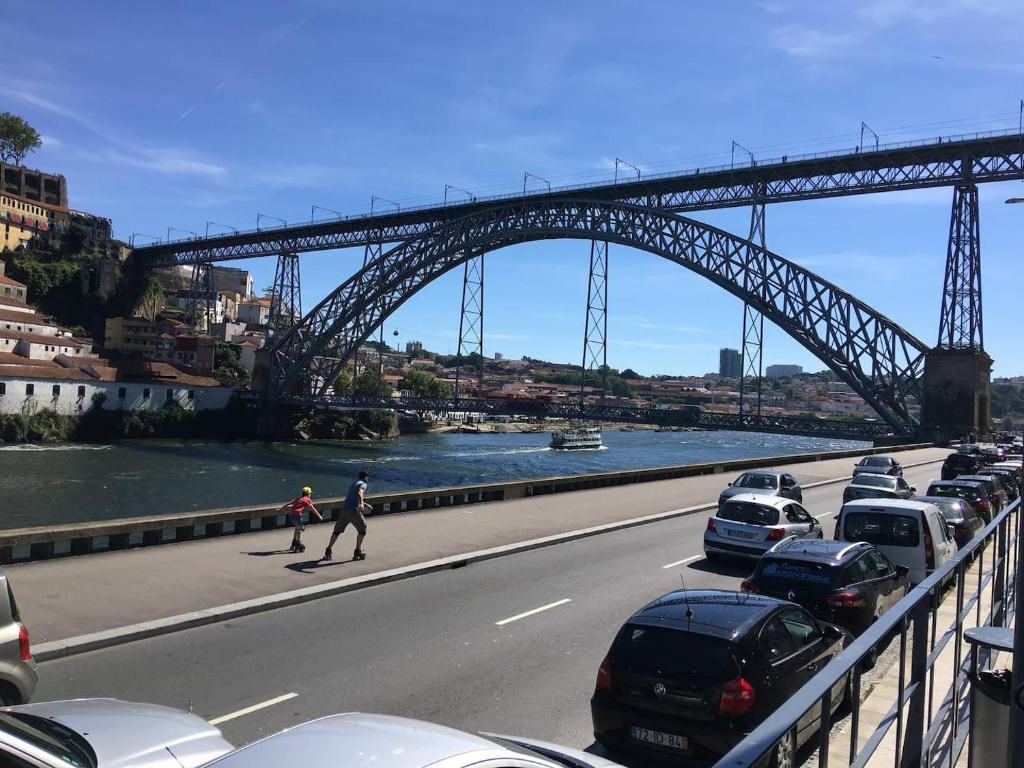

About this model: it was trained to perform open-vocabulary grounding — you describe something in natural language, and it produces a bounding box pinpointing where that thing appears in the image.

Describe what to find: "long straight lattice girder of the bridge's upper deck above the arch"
[134,132,1024,267]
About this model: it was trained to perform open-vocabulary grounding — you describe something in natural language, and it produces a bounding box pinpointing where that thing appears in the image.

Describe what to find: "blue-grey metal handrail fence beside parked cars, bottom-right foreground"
[715,500,1021,768]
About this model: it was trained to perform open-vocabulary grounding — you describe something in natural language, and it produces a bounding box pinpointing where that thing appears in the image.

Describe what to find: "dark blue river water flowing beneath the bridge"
[0,431,866,528]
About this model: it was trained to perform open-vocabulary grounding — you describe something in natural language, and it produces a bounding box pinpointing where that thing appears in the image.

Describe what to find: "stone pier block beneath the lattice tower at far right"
[921,348,992,439]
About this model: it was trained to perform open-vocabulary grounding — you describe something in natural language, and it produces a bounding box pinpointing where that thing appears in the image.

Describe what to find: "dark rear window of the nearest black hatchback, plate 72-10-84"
[611,624,736,680]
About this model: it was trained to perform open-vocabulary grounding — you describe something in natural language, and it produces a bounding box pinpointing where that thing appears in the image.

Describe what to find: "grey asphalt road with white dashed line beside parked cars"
[35,462,940,746]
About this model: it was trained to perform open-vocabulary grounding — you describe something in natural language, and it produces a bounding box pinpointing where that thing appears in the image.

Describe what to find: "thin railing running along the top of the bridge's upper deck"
[148,129,1021,250]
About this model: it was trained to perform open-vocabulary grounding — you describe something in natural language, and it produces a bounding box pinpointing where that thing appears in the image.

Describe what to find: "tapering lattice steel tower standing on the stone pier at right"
[938,182,985,349]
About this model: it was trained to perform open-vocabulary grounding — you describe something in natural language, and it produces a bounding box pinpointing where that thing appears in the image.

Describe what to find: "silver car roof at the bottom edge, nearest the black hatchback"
[201,713,514,768]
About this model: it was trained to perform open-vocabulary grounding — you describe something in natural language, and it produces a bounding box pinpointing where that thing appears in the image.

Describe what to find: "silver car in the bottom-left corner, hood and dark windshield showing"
[0,698,234,768]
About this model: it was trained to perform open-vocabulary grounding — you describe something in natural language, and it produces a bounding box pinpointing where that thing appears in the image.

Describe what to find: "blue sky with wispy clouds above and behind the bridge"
[0,0,1024,376]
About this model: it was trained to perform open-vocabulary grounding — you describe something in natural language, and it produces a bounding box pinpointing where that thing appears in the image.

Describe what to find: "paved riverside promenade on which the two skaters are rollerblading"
[12,449,949,647]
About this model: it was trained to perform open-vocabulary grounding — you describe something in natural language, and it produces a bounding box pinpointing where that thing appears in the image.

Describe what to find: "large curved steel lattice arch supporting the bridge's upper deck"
[267,199,928,434]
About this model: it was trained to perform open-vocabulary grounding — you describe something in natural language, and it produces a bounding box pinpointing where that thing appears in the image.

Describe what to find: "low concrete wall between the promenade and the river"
[0,442,933,564]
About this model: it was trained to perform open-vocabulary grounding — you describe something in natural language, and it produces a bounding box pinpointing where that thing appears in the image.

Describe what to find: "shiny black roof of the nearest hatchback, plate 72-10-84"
[630,590,787,640]
